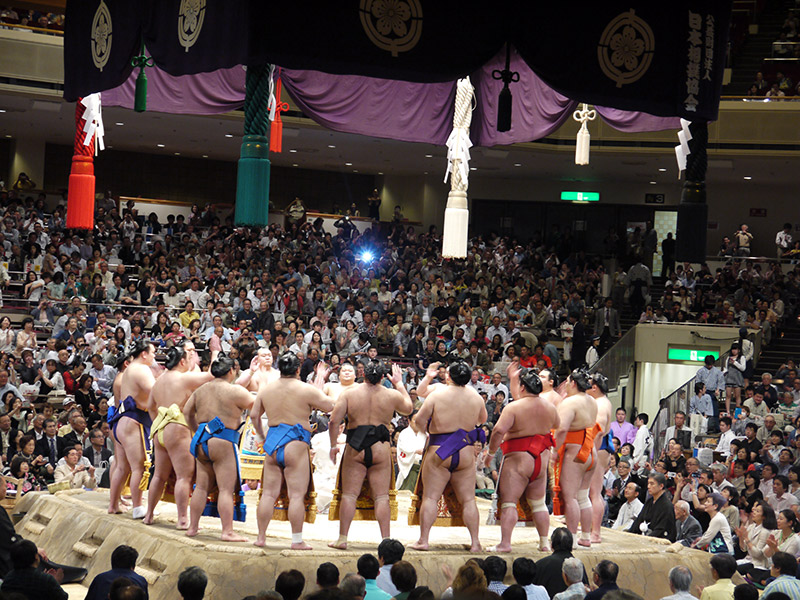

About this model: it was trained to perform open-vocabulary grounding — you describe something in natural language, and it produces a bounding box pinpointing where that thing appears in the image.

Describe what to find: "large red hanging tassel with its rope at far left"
[67,98,95,229]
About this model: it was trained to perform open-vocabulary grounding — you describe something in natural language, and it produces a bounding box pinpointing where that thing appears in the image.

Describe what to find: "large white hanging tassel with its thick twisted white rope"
[442,77,475,258]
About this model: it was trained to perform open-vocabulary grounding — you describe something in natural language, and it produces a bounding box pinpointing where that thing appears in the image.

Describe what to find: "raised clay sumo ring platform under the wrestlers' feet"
[16,490,712,600]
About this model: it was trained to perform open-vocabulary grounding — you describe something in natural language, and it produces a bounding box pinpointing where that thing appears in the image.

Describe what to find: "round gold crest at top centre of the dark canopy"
[359,0,422,57]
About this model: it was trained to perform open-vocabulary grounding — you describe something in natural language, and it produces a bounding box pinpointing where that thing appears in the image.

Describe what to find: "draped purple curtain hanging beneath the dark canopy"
[102,52,680,146]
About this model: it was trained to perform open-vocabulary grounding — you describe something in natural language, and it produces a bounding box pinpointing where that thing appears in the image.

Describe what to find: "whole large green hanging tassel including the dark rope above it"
[234,65,270,227]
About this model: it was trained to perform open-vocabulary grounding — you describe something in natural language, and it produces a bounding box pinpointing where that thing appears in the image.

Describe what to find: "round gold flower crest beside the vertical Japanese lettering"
[597,9,655,87]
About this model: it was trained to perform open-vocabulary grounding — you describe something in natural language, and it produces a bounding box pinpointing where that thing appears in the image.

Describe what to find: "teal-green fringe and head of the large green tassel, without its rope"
[234,135,270,227]
